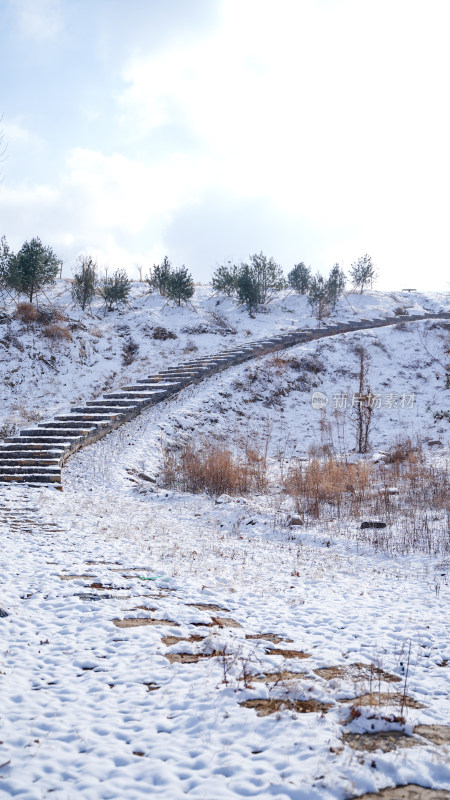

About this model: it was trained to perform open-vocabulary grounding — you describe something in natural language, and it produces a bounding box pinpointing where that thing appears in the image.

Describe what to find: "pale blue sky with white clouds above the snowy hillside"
[0,0,450,289]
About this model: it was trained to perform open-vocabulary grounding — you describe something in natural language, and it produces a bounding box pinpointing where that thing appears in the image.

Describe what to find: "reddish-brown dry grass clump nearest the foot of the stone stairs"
[162,441,267,496]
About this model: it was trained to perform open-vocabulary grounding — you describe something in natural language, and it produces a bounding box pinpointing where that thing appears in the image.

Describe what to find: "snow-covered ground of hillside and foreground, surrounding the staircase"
[0,286,450,800]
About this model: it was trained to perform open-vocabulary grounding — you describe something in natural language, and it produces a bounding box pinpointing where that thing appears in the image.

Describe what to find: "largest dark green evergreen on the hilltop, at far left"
[5,237,62,303]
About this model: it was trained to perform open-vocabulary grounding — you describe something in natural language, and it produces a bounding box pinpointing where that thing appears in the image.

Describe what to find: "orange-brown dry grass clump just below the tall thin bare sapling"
[284,457,373,519]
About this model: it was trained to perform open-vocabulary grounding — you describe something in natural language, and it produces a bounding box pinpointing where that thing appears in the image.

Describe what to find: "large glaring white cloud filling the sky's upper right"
[115,0,450,288]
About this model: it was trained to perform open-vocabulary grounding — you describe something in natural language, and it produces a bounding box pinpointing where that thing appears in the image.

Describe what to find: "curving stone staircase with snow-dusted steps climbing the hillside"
[0,312,450,486]
